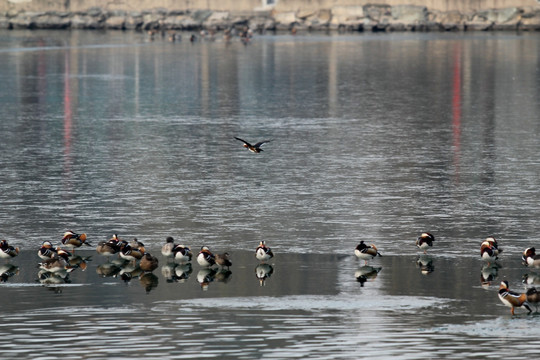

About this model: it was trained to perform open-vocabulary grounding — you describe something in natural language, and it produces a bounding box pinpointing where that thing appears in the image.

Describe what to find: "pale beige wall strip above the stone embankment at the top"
[0,0,540,12]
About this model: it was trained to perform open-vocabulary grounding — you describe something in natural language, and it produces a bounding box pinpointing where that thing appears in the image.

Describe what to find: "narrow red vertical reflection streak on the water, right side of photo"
[452,45,461,182]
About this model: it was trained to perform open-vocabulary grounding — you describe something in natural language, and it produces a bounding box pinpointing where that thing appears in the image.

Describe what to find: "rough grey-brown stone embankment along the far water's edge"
[0,5,540,32]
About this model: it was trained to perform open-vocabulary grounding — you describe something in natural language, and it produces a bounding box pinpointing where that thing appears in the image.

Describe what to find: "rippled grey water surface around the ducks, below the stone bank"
[0,31,540,359]
